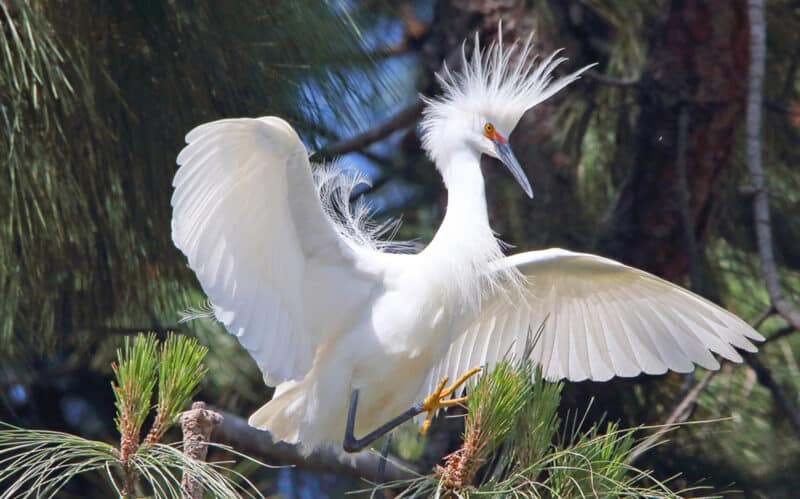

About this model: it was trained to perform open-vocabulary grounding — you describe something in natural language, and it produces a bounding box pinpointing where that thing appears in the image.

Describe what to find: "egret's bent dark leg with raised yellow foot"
[342,367,481,452]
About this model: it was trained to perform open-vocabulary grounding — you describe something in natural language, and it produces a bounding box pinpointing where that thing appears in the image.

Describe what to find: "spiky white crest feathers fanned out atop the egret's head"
[421,25,594,161]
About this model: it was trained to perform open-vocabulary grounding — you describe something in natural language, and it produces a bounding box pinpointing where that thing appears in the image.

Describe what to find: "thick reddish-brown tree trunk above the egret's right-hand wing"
[597,0,748,293]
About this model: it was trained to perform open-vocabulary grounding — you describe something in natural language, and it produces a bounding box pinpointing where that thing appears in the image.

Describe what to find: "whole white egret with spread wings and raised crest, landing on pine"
[172,30,763,452]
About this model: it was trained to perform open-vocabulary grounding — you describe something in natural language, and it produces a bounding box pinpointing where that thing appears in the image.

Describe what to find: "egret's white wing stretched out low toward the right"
[425,248,764,389]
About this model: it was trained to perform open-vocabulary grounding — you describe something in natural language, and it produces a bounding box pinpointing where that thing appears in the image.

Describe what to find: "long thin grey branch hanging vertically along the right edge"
[747,0,800,329]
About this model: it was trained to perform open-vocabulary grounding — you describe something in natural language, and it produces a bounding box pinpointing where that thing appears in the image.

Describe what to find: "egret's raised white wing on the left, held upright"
[172,117,374,384]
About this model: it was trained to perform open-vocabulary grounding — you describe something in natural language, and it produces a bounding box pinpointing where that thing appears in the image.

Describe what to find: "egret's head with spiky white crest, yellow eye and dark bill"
[421,27,591,198]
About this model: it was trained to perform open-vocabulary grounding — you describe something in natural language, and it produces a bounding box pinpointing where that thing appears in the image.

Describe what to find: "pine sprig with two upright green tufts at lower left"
[0,333,263,499]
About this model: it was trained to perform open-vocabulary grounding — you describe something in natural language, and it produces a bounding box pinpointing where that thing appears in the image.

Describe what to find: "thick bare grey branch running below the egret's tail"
[213,411,417,482]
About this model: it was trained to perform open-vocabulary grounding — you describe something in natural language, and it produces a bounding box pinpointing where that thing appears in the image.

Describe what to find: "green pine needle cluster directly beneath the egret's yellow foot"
[387,361,708,498]
